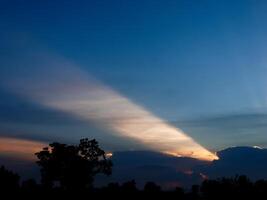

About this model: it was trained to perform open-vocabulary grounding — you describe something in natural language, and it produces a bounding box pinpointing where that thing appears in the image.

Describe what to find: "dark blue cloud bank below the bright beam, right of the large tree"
[96,151,208,189]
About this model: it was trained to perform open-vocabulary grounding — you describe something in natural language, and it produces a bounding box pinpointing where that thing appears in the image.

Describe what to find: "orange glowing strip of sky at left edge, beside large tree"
[0,137,47,161]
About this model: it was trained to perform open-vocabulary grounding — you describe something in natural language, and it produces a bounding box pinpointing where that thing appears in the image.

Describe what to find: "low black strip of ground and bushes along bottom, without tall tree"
[3,176,267,200]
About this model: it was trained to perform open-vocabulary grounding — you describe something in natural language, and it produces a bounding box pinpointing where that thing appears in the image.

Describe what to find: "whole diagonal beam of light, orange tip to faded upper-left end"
[2,54,218,161]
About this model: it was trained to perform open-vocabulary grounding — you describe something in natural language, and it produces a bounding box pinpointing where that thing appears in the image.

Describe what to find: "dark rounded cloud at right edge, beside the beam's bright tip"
[194,147,267,180]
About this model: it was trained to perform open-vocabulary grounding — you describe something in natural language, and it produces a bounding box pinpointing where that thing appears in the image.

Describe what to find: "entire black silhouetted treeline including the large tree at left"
[0,139,267,199]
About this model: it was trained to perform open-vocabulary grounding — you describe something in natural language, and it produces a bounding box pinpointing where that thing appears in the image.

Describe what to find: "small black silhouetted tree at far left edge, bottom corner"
[0,166,20,192]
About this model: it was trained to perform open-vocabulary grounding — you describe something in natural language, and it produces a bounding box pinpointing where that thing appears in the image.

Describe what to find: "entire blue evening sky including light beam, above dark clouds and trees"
[0,0,267,162]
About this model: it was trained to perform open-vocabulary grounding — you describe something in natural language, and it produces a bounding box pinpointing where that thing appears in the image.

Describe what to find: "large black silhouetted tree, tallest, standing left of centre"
[36,138,112,190]
